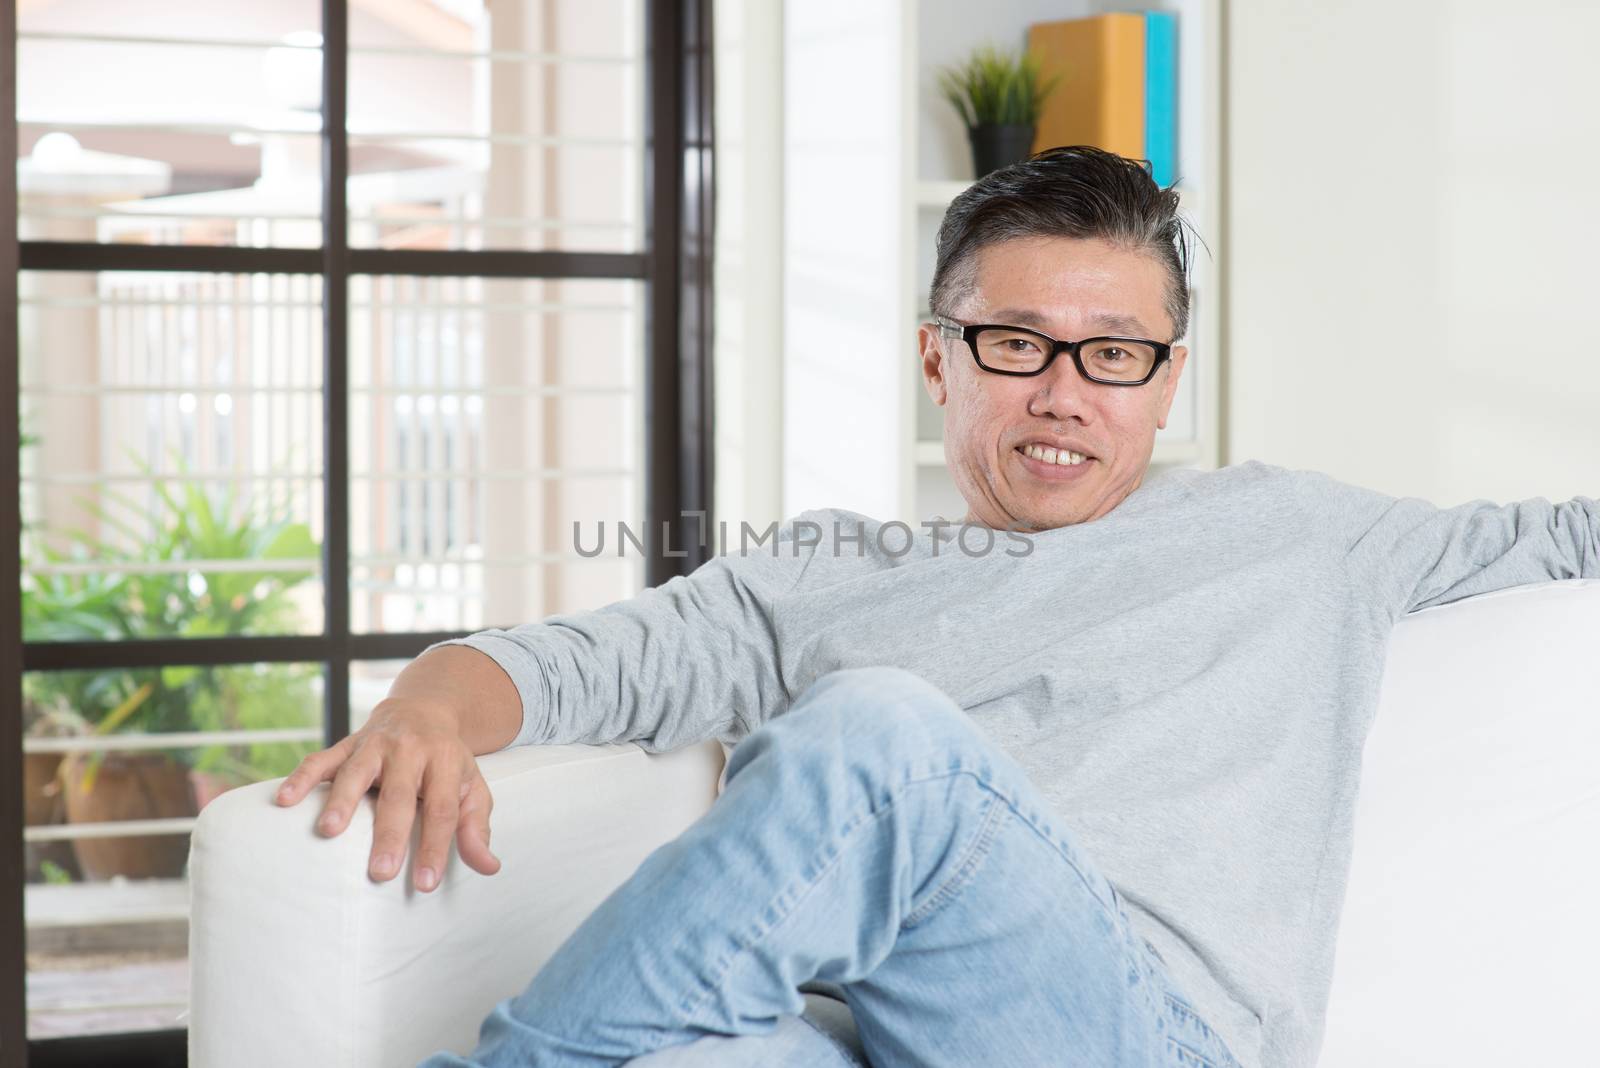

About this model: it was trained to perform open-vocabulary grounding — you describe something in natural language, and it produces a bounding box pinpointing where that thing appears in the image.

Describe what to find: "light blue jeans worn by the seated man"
[422,668,1237,1068]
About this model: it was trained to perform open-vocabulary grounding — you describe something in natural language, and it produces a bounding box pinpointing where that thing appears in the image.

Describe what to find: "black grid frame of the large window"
[0,0,714,1068]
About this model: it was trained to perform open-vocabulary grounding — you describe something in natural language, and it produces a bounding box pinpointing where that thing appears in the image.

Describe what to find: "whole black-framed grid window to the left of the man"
[0,0,710,1066]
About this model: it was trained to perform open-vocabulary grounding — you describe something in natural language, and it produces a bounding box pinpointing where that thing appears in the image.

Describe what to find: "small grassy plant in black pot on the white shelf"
[939,45,1058,177]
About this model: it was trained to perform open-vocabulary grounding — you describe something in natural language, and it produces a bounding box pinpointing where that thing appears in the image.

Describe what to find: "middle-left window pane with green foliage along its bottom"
[18,272,323,641]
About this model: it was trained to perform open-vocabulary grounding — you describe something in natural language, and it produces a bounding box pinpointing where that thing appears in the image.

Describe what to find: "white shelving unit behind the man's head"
[782,0,1221,521]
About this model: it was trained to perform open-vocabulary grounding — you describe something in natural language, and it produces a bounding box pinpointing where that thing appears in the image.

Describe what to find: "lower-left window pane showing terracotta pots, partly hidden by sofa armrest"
[22,664,323,1038]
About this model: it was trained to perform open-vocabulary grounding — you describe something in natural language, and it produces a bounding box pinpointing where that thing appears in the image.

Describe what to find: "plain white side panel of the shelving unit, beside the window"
[782,0,912,516]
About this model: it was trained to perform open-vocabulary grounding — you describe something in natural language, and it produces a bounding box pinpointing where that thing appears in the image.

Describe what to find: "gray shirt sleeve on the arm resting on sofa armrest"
[419,513,814,753]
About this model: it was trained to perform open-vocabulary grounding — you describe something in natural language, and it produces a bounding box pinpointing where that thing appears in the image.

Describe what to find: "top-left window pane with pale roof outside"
[18,0,322,246]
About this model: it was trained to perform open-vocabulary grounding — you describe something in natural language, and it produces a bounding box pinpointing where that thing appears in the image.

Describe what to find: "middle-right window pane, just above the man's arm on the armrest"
[350,277,643,632]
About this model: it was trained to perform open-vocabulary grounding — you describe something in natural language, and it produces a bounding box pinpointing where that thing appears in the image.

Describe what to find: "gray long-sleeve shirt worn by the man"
[438,464,1600,1068]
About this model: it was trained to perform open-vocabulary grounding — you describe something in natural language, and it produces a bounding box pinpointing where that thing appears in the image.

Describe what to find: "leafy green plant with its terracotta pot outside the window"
[22,478,317,879]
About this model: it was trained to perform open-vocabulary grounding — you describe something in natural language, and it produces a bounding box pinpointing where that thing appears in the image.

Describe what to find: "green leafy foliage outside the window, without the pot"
[22,463,320,782]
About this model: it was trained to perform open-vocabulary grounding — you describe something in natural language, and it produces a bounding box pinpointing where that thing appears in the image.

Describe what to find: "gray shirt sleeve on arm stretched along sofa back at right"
[1341,476,1600,617]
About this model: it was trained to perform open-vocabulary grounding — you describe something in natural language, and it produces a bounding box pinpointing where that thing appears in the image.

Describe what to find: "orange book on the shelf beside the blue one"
[1027,14,1146,160]
